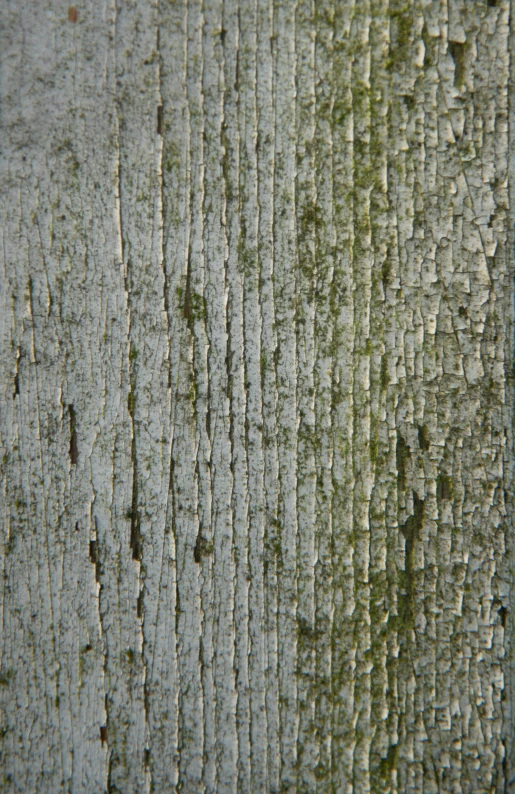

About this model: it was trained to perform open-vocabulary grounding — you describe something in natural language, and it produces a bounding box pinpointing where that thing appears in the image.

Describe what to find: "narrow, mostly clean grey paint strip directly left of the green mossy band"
[273,2,298,788]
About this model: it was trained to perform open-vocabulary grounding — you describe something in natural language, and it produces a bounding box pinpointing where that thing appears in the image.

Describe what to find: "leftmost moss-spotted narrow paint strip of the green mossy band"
[295,0,318,790]
